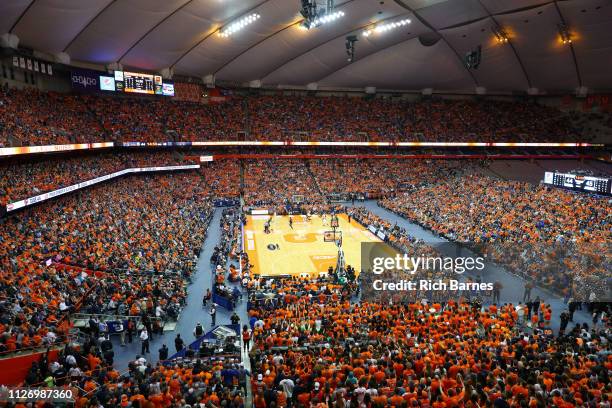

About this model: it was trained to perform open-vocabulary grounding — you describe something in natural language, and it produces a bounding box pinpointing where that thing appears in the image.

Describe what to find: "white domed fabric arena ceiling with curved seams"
[0,0,612,92]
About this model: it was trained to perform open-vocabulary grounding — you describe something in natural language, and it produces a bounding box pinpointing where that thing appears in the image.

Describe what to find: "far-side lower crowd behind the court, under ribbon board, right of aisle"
[244,159,478,206]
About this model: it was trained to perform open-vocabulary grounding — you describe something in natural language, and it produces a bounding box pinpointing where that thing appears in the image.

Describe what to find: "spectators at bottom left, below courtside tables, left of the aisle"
[18,342,248,408]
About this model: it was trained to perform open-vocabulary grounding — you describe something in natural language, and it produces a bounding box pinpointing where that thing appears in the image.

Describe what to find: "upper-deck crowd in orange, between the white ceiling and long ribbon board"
[0,88,588,146]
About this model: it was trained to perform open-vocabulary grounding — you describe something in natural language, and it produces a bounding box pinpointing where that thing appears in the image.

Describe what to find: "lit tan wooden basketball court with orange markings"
[243,214,392,277]
